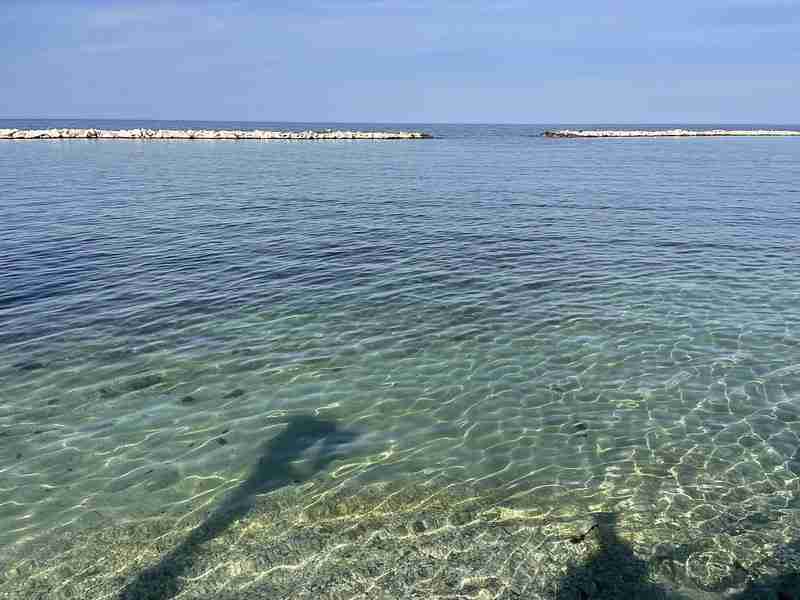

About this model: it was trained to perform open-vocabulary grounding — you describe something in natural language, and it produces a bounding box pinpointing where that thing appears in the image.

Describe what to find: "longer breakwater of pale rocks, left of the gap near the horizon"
[0,128,432,140]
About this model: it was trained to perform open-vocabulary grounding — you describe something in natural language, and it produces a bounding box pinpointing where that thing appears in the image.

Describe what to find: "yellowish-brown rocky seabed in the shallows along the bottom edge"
[0,482,800,600]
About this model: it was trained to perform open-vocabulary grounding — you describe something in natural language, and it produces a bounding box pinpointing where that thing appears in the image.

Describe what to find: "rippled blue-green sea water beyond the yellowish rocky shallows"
[0,121,800,597]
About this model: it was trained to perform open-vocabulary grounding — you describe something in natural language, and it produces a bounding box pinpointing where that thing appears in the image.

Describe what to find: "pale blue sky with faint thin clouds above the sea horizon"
[0,0,800,124]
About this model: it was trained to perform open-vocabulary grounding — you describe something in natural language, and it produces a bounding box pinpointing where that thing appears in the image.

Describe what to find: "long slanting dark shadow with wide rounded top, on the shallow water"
[119,415,356,600]
